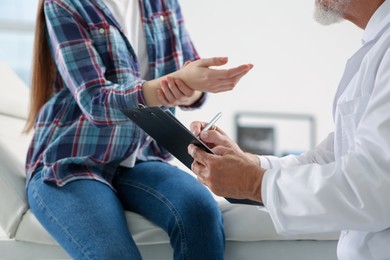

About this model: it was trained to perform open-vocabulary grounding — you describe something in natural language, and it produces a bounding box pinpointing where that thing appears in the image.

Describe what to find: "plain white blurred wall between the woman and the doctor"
[179,0,363,151]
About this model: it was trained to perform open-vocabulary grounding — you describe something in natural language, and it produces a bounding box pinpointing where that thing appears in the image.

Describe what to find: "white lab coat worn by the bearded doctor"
[261,1,390,260]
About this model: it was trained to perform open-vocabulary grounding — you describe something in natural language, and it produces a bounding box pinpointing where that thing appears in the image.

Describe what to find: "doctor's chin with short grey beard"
[314,0,351,25]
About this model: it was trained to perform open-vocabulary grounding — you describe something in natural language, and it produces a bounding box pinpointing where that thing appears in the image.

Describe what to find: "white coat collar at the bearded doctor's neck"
[362,1,390,44]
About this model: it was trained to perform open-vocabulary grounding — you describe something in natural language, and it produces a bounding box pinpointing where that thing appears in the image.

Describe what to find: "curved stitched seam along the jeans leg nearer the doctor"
[116,181,187,259]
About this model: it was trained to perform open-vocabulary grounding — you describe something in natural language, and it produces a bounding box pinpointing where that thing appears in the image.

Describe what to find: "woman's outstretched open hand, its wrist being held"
[170,57,253,93]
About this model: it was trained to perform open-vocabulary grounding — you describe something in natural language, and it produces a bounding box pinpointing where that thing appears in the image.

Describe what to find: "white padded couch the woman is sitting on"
[0,63,338,260]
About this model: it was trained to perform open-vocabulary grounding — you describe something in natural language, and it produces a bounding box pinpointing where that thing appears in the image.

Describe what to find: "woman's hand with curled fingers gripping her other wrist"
[157,76,202,107]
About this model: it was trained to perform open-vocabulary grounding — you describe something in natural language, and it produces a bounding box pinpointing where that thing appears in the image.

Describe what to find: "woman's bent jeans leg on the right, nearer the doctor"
[113,161,224,259]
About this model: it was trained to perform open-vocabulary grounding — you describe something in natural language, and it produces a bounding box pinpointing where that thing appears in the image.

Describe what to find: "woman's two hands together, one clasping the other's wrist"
[142,58,253,106]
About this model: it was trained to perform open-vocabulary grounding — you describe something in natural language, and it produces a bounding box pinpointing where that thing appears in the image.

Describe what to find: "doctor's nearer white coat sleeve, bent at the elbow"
[262,51,390,235]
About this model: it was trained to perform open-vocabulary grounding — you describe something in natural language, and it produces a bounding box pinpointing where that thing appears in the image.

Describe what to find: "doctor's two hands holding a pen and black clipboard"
[188,122,265,202]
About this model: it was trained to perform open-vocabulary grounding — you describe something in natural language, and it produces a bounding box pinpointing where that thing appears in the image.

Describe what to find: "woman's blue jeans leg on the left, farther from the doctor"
[28,172,140,259]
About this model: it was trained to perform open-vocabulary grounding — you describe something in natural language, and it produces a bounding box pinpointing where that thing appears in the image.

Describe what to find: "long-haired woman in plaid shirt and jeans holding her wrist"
[26,0,252,259]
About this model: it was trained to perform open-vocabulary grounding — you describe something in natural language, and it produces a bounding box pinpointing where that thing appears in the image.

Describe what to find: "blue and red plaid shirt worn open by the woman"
[26,0,204,186]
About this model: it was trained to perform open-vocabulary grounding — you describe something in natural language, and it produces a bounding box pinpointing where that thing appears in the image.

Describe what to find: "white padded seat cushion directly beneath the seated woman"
[15,198,339,245]
